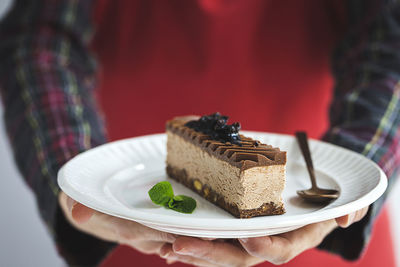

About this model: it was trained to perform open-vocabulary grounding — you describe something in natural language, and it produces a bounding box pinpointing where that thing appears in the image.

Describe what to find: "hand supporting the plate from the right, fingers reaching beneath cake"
[160,207,368,266]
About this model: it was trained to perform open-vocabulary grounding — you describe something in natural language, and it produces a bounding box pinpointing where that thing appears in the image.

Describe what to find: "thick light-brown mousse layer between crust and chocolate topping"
[167,130,285,215]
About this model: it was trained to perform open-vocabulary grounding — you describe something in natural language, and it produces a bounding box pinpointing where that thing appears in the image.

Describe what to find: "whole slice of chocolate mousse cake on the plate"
[166,113,286,218]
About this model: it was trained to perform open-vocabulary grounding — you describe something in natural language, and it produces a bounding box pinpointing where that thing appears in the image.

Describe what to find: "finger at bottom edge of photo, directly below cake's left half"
[172,237,254,266]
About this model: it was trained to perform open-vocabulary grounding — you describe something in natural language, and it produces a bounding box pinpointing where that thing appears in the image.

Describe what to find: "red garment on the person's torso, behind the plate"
[93,0,394,266]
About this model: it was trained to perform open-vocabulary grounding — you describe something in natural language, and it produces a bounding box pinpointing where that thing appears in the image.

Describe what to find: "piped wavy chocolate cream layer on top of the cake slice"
[166,117,286,170]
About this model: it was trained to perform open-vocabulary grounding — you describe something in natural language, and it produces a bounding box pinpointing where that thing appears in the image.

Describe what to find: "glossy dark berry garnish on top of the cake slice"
[185,112,241,145]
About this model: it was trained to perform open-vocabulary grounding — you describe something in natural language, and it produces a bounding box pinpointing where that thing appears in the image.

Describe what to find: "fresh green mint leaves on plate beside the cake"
[149,181,196,213]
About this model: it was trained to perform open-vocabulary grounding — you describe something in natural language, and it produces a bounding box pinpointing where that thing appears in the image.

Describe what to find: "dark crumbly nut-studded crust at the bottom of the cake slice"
[167,164,285,218]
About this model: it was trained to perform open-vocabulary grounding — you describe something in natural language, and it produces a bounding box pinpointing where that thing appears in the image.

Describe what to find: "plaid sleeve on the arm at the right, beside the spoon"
[320,0,400,260]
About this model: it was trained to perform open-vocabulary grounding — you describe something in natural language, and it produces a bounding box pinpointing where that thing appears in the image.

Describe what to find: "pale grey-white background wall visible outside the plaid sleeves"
[0,0,400,267]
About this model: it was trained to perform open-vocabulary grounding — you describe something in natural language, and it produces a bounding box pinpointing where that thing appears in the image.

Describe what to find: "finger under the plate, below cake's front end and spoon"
[239,220,337,264]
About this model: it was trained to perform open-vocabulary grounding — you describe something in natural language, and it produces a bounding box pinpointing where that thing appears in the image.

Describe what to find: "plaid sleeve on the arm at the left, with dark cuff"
[0,0,114,266]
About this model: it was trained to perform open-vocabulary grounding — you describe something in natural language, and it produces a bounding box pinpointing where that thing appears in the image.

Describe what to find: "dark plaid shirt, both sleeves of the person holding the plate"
[0,0,400,265]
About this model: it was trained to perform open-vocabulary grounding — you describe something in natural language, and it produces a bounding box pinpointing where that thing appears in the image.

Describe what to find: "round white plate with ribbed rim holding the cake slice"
[58,132,387,238]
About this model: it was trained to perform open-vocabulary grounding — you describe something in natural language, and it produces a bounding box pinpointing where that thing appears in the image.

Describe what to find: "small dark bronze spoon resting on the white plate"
[296,132,339,202]
